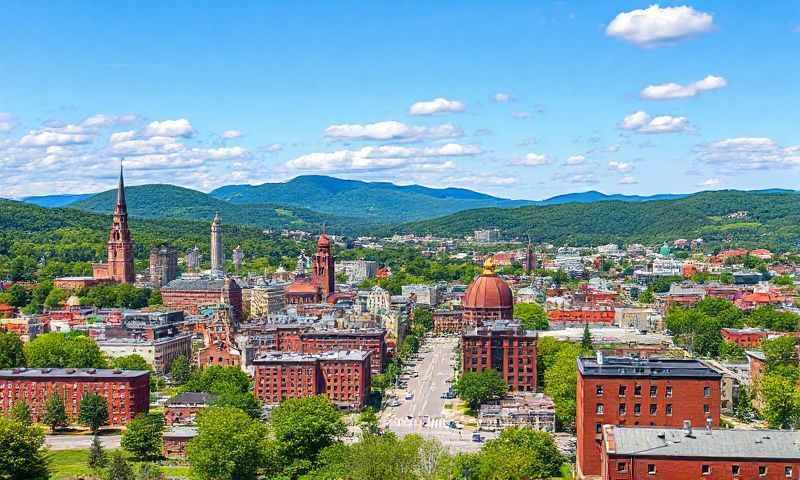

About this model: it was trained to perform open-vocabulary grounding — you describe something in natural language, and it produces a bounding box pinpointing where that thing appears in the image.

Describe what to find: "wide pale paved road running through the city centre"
[381,338,494,452]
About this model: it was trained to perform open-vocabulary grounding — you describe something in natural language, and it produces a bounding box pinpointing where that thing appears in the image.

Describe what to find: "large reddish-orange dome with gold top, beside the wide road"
[461,257,514,327]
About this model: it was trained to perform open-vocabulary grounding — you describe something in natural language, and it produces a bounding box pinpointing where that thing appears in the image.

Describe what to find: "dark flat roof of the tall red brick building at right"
[577,357,722,380]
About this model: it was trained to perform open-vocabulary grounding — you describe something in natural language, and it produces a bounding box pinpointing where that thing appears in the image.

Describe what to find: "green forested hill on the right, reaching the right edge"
[395,190,800,249]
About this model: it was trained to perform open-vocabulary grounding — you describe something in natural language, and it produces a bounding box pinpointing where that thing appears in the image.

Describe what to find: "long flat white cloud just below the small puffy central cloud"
[325,120,464,140]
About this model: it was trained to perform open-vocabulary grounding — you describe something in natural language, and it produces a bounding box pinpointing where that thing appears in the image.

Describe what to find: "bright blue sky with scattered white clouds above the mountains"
[0,0,800,200]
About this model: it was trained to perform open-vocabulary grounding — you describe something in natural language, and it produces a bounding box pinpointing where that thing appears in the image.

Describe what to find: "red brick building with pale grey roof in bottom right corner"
[601,425,800,480]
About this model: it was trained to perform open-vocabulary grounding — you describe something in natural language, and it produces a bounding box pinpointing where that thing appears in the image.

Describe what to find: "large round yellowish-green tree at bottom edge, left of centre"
[187,407,267,480]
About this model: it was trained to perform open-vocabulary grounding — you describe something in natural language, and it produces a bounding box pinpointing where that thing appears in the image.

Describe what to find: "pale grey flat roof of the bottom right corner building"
[603,425,800,461]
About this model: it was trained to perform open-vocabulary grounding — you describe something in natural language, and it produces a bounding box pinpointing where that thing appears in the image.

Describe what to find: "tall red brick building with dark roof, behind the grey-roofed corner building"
[575,355,722,479]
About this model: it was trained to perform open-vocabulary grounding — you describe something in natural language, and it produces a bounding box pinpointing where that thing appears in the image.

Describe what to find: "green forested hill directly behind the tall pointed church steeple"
[69,184,369,234]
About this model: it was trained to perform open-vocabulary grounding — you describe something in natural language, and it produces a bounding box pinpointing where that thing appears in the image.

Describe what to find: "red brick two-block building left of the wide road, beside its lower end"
[253,350,372,410]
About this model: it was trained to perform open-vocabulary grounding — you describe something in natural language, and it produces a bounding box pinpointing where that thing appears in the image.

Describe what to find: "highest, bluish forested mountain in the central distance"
[211,175,533,223]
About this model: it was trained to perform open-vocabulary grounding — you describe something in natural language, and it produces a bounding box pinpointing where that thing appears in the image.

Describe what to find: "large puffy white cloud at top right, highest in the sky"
[606,5,714,47]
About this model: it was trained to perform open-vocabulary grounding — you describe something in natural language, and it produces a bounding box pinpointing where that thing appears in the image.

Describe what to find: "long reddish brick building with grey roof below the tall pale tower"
[161,278,242,321]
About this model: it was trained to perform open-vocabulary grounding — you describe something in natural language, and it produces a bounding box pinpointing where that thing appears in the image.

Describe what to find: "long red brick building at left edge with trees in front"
[0,368,150,425]
